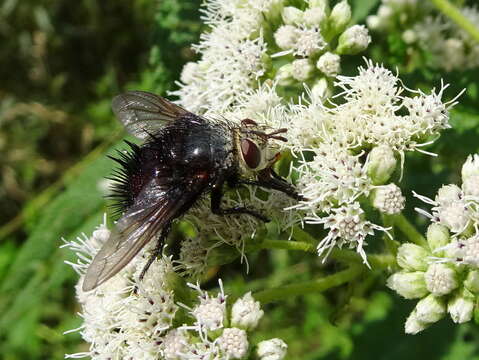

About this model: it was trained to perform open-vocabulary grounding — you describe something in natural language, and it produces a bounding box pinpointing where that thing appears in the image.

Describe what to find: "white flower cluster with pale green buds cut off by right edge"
[388,155,479,334]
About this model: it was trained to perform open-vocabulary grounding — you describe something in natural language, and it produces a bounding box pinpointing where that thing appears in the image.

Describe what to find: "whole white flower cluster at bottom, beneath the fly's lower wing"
[64,219,287,360]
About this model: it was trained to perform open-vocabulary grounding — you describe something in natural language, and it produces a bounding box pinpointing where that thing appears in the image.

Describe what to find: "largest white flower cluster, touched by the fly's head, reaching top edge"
[173,0,460,273]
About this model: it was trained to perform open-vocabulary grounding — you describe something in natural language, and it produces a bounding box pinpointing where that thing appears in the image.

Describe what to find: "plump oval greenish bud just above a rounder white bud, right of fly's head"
[367,145,397,185]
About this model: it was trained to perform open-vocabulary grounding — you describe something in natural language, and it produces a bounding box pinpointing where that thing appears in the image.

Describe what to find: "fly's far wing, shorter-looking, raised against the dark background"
[111,91,196,139]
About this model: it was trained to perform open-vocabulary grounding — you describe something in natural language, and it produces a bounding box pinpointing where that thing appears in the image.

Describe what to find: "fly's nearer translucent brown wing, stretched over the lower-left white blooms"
[83,178,207,291]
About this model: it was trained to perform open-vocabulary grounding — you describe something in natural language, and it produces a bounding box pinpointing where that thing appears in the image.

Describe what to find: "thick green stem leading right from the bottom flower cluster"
[253,265,363,304]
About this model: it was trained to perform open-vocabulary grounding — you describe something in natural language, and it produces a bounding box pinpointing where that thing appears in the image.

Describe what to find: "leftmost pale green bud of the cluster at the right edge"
[386,271,428,299]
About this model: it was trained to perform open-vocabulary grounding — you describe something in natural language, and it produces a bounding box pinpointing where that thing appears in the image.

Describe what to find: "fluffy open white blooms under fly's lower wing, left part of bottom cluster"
[62,215,178,359]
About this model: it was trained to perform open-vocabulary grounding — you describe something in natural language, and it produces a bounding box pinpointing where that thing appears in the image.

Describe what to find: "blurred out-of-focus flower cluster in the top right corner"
[367,0,479,71]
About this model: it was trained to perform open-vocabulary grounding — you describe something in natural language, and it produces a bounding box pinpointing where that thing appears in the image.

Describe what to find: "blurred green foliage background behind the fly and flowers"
[0,0,479,360]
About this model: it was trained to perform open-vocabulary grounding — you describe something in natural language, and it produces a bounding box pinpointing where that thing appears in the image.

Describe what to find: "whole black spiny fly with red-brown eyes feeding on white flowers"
[83,91,302,291]
